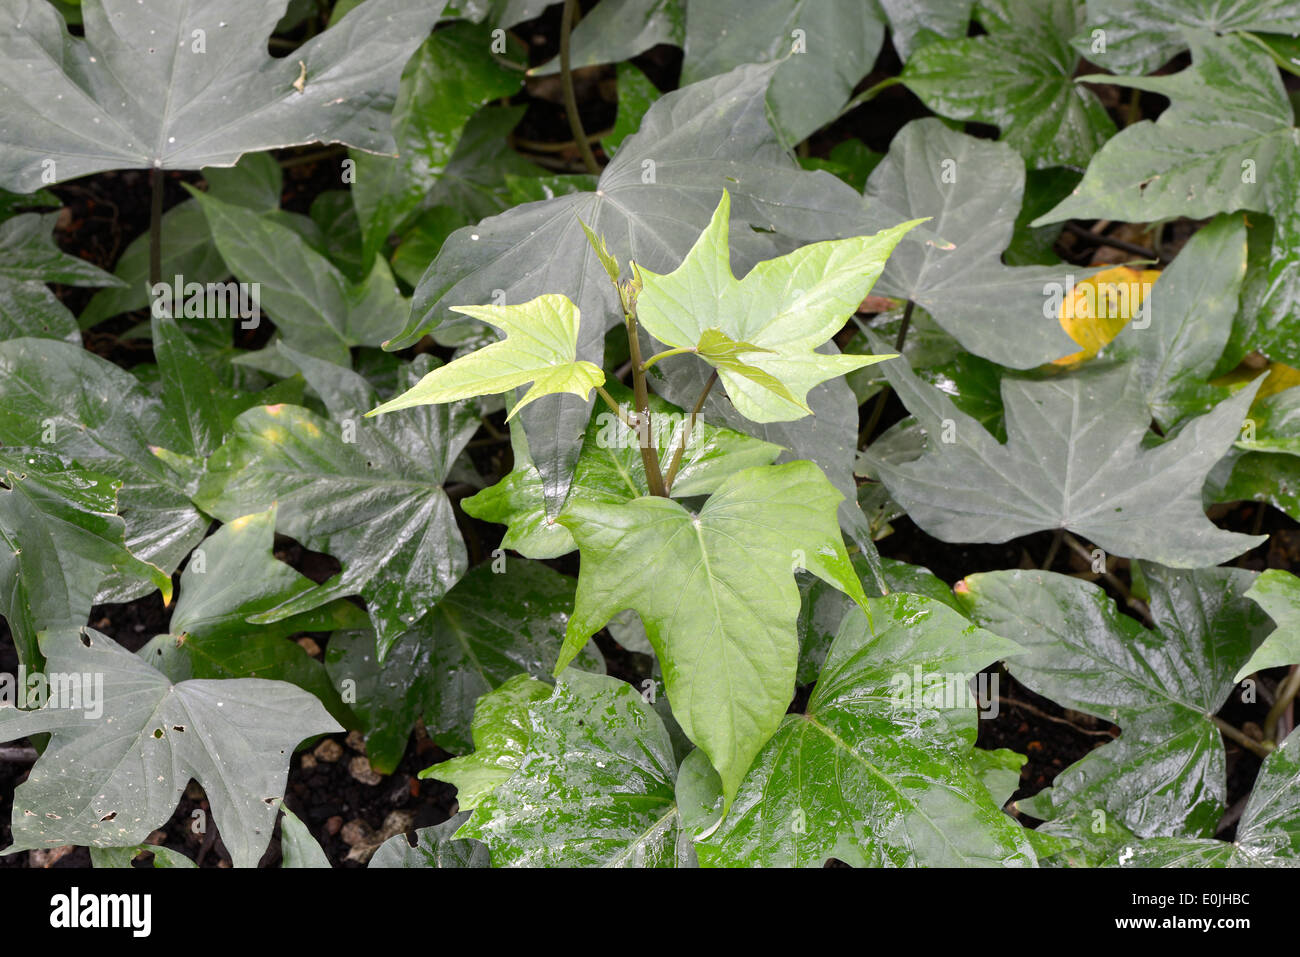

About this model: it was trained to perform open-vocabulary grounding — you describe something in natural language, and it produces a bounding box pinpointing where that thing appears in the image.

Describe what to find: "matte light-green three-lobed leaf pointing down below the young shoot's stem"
[556,462,866,802]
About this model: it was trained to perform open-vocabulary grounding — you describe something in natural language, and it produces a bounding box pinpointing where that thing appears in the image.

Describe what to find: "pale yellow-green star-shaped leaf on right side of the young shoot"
[637,190,923,423]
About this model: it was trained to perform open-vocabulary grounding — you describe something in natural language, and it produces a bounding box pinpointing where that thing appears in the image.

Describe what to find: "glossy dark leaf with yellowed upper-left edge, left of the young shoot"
[195,348,478,654]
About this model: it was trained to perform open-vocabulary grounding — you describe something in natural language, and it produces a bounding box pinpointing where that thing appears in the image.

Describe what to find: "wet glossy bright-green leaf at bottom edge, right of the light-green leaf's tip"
[683,594,1035,867]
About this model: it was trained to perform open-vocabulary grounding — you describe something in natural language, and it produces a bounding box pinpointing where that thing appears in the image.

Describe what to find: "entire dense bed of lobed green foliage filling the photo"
[0,0,1300,867]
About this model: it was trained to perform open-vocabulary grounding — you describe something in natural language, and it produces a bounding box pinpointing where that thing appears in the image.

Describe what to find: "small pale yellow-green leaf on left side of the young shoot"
[367,295,605,419]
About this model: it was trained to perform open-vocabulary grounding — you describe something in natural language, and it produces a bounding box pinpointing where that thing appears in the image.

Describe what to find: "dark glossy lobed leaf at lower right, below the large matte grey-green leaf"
[959,564,1270,837]
